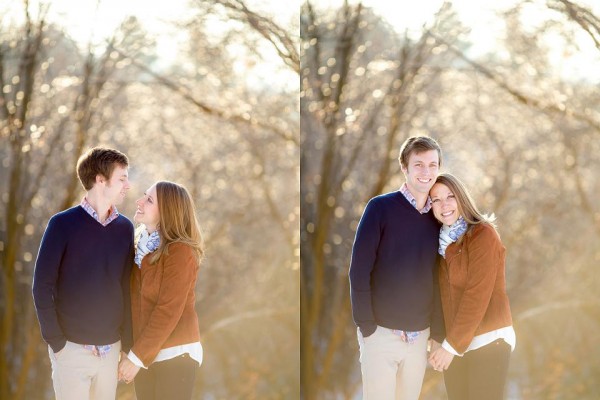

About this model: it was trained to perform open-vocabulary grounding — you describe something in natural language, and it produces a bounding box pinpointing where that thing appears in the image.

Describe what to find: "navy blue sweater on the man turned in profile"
[33,206,133,352]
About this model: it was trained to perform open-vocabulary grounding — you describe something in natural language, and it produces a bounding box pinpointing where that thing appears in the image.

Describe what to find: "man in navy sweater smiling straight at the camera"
[349,136,444,400]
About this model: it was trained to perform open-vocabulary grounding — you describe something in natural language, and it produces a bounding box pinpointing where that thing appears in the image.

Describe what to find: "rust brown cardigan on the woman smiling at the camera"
[439,223,512,354]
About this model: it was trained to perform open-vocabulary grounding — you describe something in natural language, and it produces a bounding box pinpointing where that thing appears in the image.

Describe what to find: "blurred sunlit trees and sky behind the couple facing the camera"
[300,0,600,400]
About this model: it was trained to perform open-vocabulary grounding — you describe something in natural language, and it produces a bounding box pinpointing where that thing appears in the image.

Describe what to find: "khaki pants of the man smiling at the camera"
[358,326,429,400]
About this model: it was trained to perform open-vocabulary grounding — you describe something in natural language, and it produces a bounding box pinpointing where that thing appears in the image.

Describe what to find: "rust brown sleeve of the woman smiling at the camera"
[446,225,500,354]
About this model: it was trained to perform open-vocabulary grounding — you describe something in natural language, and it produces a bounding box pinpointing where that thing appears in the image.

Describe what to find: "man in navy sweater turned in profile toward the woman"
[33,147,133,400]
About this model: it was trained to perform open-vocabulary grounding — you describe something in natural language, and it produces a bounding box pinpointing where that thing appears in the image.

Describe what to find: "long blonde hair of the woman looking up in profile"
[139,181,204,264]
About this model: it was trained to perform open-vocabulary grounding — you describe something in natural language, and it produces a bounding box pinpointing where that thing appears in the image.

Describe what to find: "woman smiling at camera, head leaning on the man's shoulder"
[429,173,516,400]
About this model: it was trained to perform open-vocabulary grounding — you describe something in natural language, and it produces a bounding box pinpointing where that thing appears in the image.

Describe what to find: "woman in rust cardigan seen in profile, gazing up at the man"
[119,181,203,400]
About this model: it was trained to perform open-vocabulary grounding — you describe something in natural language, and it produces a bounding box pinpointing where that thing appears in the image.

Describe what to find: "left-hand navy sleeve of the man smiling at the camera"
[349,200,381,337]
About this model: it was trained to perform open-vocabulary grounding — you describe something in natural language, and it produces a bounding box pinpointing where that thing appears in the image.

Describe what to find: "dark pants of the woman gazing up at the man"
[134,354,198,400]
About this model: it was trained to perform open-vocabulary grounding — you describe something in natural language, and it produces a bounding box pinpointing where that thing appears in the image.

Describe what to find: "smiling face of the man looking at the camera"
[402,150,440,196]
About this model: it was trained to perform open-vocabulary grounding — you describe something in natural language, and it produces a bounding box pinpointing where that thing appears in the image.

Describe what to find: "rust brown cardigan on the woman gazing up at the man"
[131,243,200,367]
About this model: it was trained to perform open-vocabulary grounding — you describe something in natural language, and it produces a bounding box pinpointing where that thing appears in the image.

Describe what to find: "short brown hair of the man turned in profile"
[77,147,129,190]
